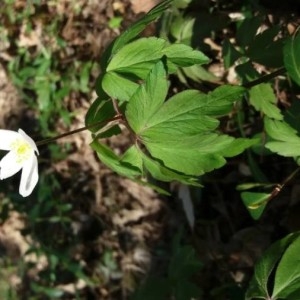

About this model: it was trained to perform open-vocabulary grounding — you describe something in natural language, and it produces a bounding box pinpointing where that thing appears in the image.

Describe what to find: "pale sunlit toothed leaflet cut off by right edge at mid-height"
[264,118,300,157]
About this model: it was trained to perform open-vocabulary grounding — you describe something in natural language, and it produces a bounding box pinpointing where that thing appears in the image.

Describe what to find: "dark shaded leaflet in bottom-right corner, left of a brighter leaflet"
[246,233,299,300]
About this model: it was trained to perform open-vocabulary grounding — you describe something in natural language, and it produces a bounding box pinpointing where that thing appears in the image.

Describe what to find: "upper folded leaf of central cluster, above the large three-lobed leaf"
[98,37,208,102]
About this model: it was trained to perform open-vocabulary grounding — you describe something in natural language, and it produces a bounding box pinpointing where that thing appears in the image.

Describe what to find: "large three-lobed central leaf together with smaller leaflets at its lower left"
[92,55,253,189]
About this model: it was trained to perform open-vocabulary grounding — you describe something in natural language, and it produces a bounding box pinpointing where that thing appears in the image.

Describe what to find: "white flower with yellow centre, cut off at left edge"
[0,129,39,197]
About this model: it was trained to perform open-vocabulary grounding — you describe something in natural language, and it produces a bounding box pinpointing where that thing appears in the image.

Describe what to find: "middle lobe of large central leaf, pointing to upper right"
[137,86,245,141]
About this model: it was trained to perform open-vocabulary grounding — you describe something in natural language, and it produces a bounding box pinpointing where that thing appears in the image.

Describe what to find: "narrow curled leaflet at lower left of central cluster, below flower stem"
[91,140,141,179]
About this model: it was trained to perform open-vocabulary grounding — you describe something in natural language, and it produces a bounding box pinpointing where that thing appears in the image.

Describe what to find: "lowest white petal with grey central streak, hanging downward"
[19,152,39,197]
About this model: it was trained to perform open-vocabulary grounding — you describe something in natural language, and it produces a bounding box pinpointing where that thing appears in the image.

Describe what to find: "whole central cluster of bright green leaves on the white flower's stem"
[86,2,254,192]
